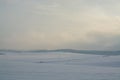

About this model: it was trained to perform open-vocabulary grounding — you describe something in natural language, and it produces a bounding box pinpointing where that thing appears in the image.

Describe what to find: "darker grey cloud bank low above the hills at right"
[63,32,120,50]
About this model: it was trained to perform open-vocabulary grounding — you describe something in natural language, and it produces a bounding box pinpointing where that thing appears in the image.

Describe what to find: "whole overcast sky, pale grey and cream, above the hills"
[0,0,120,50]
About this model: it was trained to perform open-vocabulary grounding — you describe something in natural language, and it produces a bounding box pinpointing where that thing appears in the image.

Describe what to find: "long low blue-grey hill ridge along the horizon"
[0,49,120,55]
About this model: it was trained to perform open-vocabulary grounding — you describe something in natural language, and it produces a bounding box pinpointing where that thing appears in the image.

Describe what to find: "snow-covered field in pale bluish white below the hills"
[0,52,120,80]
